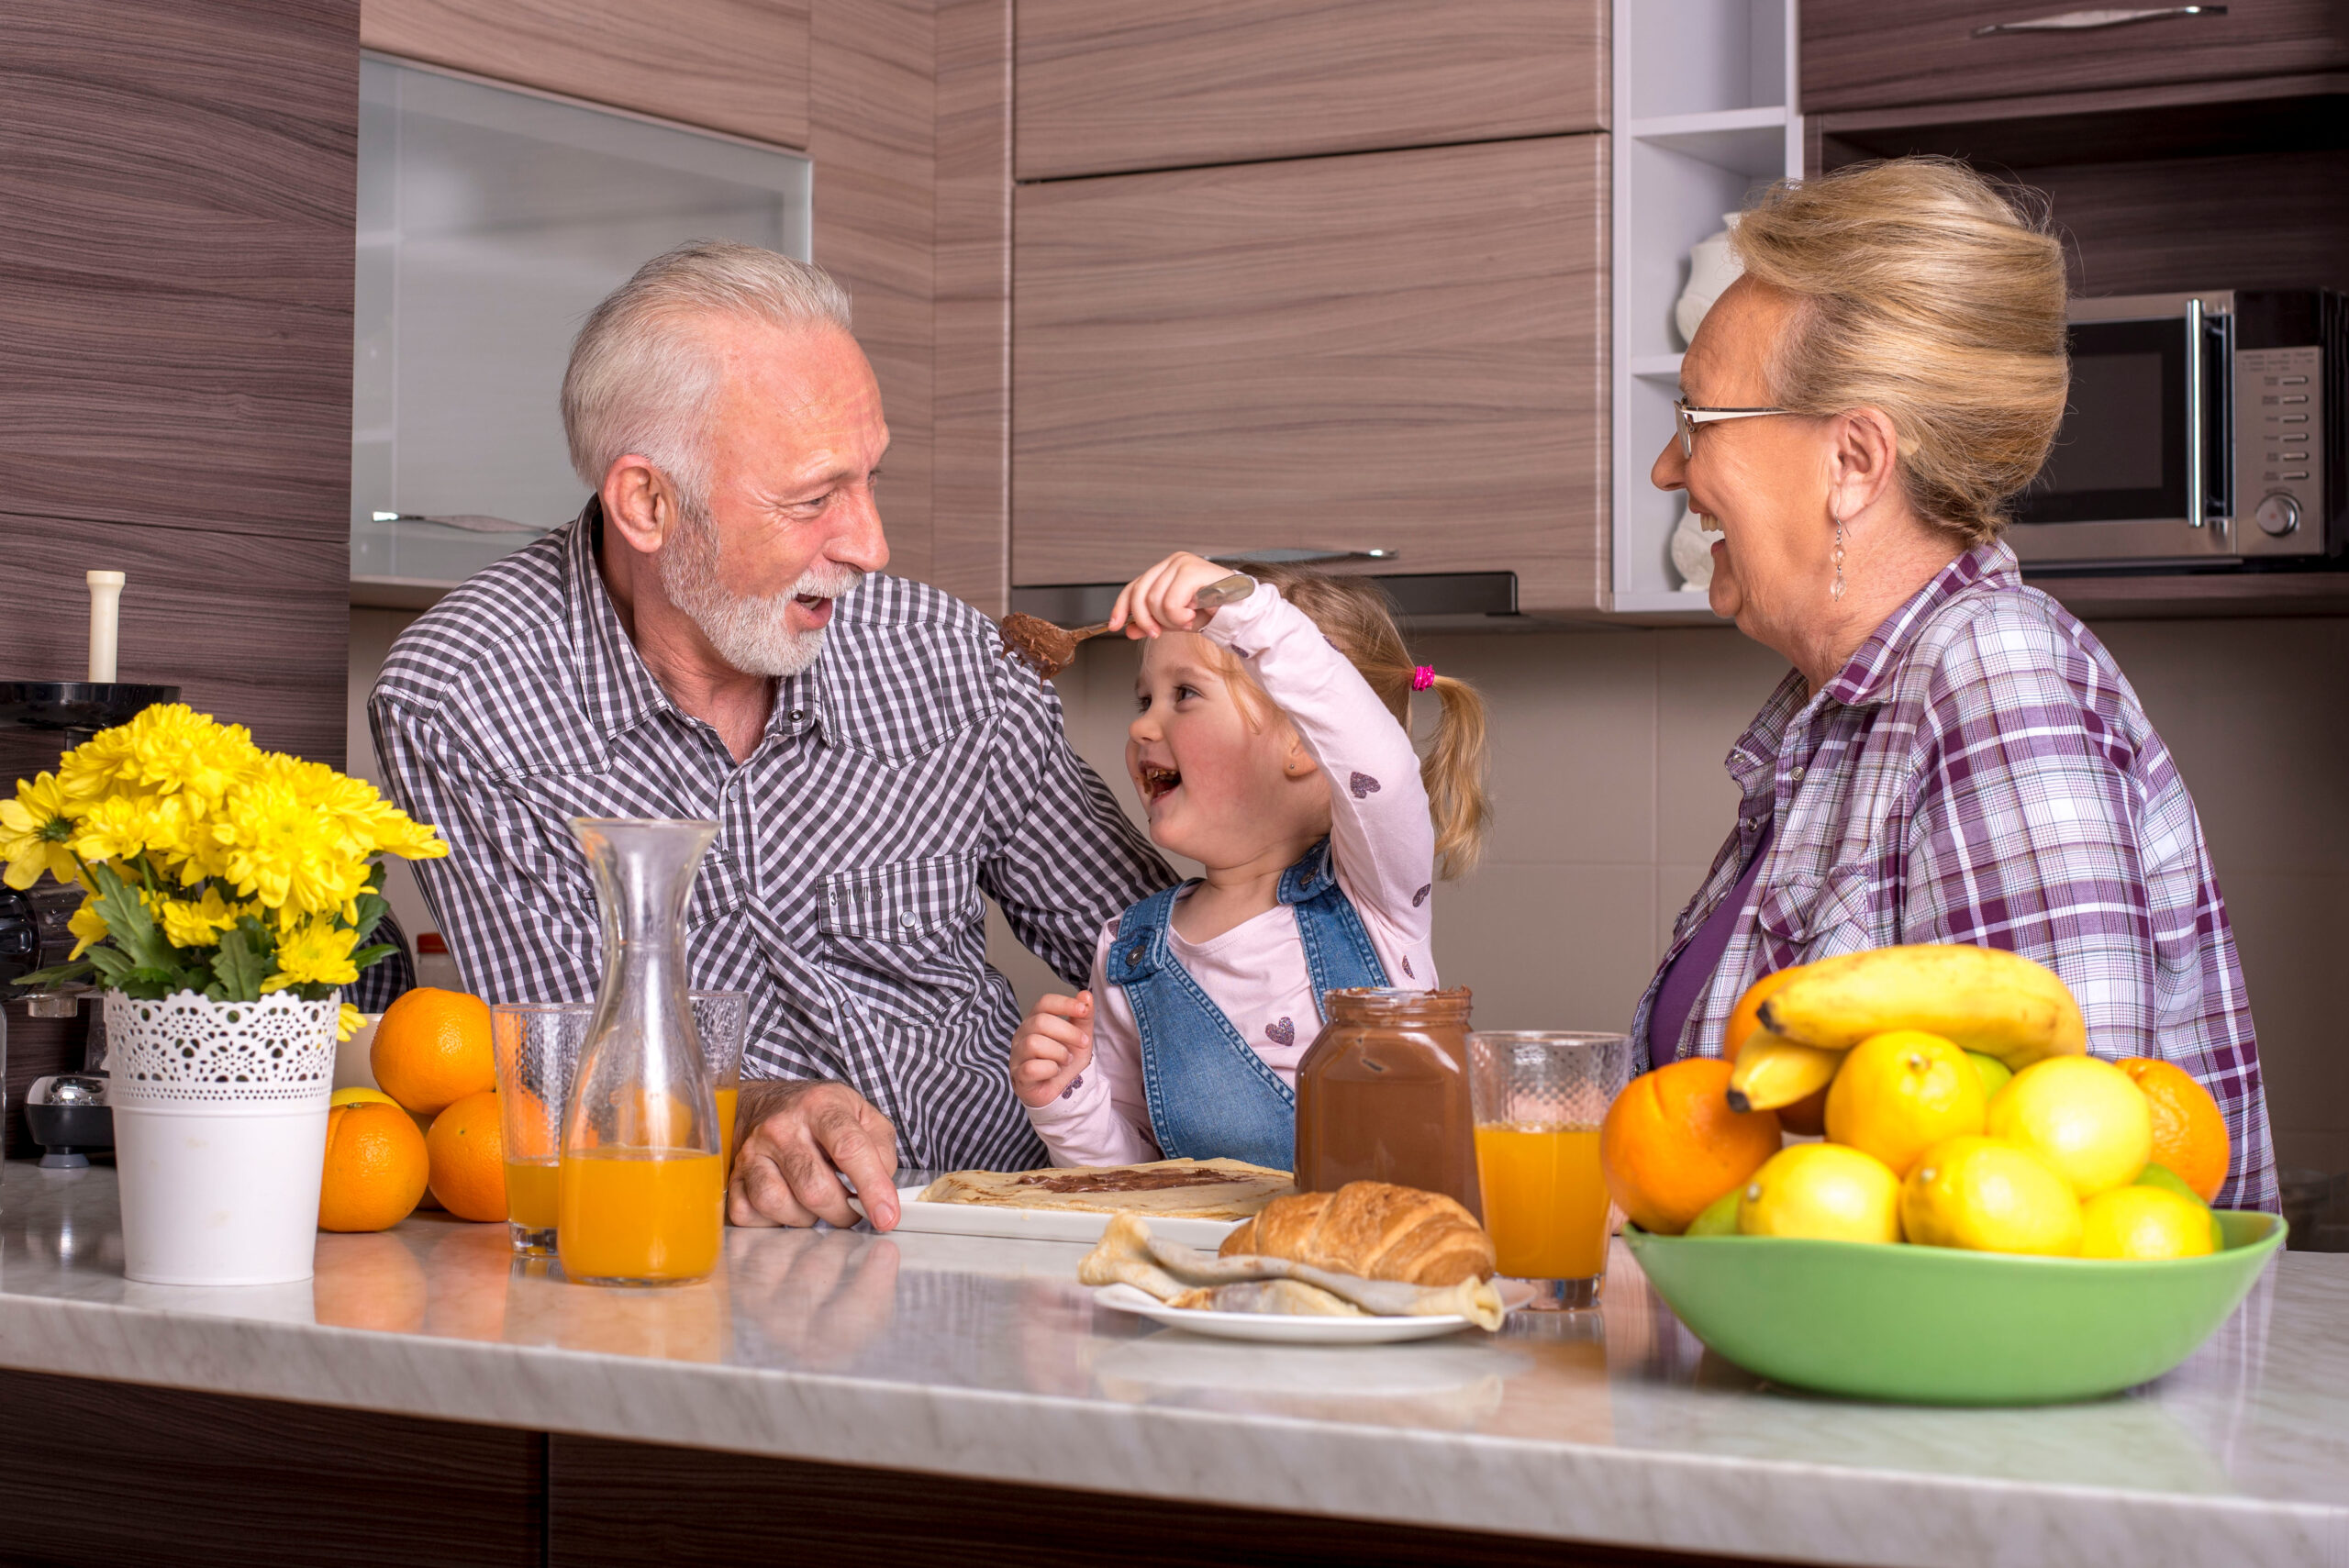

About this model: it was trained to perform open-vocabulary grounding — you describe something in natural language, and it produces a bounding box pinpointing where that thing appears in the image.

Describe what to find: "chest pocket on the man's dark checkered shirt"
[818,857,982,1014]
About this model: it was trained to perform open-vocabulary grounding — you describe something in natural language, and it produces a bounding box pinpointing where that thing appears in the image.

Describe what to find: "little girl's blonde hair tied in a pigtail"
[1229,566,1492,878]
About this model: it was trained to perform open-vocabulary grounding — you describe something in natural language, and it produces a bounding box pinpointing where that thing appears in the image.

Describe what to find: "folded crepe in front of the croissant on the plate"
[1075,1214,1501,1329]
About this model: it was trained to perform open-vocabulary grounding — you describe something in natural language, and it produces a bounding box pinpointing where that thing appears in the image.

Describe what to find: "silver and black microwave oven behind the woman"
[2006,289,2349,571]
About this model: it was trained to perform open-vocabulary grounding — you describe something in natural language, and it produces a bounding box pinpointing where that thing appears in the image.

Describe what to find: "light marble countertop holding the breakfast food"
[0,1162,2349,1568]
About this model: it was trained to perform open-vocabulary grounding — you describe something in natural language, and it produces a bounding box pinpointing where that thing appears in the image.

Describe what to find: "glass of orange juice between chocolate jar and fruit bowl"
[1468,1030,1631,1312]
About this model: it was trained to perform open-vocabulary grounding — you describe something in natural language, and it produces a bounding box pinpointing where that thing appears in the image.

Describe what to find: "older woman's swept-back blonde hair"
[1733,157,2072,545]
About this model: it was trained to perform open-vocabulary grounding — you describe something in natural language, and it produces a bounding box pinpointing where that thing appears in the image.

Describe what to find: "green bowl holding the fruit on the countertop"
[1623,1209,2283,1404]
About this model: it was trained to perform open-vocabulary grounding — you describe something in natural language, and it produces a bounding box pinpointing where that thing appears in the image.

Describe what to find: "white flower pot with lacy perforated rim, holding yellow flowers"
[106,991,340,1286]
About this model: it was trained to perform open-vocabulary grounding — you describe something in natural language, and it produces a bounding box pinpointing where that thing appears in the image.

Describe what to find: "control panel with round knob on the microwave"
[2234,345,2325,556]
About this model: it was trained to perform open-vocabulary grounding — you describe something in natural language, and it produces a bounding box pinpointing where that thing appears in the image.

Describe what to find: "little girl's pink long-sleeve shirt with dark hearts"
[1029,584,1438,1164]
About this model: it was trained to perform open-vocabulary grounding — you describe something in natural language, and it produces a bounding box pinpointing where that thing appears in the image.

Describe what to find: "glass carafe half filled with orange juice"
[554,817,726,1284]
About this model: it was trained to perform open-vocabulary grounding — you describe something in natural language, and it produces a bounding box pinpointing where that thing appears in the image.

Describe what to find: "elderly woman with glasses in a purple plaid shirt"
[1632,160,2277,1209]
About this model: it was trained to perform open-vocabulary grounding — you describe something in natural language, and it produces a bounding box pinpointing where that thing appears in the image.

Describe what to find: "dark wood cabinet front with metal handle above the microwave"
[1802,0,2349,115]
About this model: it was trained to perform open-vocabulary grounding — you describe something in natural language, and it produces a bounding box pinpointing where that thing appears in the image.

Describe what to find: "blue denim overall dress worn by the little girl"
[1102,838,1386,1172]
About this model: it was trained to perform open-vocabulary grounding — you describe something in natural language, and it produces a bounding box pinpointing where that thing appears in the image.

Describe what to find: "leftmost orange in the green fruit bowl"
[1599,1056,1780,1237]
